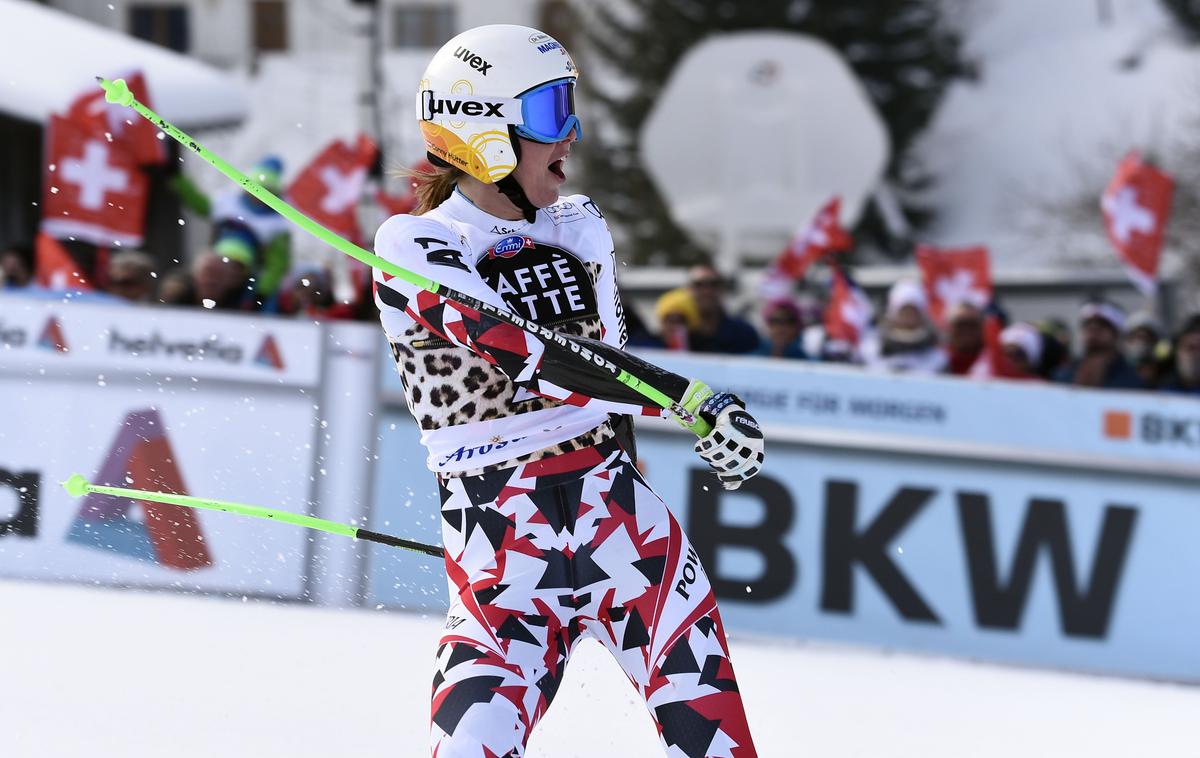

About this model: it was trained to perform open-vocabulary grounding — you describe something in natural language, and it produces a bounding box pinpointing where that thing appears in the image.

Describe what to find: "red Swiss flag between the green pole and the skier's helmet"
[287,134,376,242]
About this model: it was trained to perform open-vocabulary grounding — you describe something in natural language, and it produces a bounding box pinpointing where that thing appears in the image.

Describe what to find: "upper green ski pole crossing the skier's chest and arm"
[96,77,712,437]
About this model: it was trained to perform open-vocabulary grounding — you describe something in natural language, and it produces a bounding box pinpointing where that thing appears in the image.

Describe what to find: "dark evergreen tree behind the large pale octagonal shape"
[581,0,970,264]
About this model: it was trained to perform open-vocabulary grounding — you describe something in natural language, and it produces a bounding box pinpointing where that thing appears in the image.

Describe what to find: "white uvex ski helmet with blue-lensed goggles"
[416,24,582,187]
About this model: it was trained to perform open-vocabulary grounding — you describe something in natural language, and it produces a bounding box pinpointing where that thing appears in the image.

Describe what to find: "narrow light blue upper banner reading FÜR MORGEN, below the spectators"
[643,351,1200,476]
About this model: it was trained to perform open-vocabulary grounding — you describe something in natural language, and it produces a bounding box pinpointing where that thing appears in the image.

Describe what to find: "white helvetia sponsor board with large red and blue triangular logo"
[0,292,322,597]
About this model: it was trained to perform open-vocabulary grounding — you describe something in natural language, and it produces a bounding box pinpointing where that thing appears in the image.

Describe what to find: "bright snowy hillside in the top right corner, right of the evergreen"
[920,0,1200,269]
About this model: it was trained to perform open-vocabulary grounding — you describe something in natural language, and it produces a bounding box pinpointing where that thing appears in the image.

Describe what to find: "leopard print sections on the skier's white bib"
[391,261,614,476]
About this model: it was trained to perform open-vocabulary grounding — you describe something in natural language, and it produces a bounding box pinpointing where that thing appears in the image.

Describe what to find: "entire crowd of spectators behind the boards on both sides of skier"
[0,223,1200,395]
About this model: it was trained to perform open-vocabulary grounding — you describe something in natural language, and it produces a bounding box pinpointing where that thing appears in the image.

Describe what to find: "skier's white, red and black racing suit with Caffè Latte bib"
[374,191,756,758]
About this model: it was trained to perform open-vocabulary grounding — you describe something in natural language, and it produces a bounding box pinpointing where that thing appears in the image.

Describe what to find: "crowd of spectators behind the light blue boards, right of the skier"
[626,265,1200,395]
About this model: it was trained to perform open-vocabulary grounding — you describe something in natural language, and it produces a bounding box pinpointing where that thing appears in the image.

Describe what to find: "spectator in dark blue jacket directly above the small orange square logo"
[1055,300,1145,390]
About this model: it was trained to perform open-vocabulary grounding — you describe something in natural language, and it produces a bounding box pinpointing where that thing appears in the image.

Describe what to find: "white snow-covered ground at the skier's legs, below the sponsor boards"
[0,582,1200,758]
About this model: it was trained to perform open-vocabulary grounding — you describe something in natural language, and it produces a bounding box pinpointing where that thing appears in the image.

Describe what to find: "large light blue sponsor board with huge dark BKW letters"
[638,424,1200,681]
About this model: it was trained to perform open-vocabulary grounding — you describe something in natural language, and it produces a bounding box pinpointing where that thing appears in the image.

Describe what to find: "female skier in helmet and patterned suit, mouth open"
[374,25,763,758]
